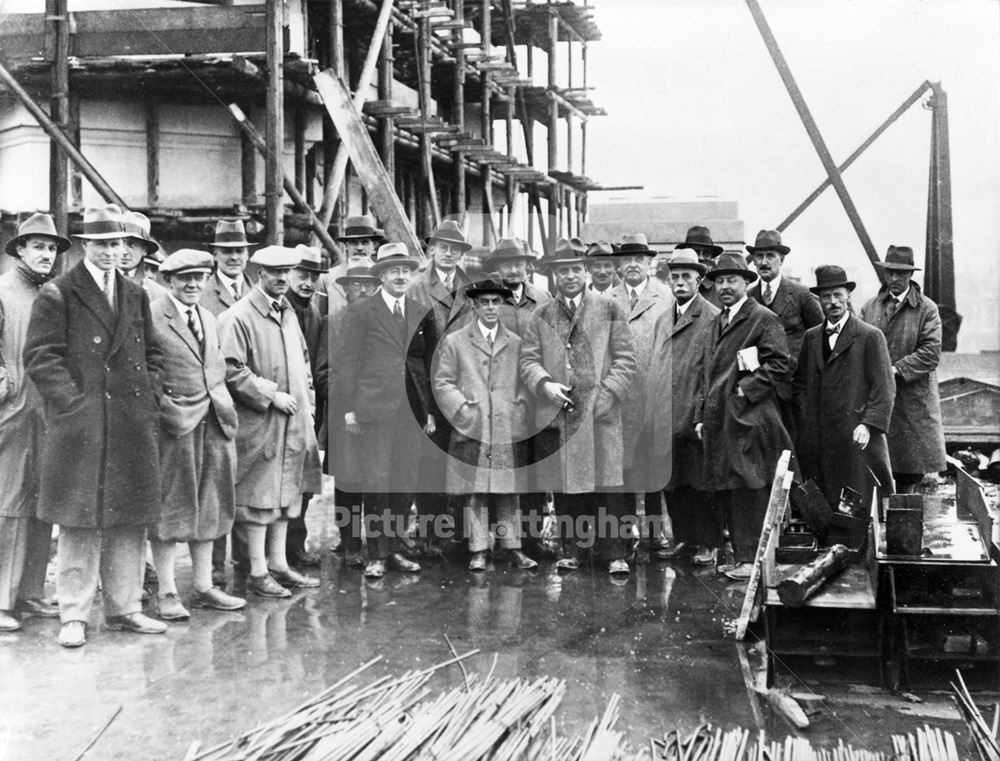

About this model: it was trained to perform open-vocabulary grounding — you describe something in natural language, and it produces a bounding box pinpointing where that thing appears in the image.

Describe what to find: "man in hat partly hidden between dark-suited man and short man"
[409,219,472,559]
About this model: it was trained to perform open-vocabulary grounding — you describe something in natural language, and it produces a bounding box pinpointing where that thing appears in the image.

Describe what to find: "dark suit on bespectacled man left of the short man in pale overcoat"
[331,293,430,558]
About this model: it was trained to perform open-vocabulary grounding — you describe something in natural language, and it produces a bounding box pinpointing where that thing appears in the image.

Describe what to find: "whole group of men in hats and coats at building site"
[0,205,945,647]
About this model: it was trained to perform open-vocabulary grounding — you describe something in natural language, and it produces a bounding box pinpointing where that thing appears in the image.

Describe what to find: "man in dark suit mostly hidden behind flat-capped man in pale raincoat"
[285,243,330,567]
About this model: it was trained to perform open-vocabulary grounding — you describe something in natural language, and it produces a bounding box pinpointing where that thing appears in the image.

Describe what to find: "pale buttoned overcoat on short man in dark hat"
[432,320,529,494]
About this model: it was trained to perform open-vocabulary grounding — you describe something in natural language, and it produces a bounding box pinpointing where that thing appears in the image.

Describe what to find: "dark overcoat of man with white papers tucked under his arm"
[696,298,792,491]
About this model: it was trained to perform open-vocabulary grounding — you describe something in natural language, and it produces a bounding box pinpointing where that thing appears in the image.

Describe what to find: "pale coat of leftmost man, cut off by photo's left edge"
[0,267,45,518]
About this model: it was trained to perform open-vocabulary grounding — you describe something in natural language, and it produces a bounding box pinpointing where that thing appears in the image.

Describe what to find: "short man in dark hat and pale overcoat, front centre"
[433,280,538,571]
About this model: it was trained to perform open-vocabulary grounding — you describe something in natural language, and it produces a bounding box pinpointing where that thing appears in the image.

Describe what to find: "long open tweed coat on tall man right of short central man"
[520,289,635,494]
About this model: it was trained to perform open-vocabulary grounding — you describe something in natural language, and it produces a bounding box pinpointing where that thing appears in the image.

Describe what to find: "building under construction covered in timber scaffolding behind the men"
[0,0,603,266]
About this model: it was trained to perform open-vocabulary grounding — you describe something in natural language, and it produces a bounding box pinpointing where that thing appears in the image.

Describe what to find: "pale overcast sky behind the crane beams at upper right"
[587,0,1000,351]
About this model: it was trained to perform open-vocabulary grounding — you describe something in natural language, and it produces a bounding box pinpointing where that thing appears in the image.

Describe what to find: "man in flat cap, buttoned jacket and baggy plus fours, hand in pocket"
[150,248,246,621]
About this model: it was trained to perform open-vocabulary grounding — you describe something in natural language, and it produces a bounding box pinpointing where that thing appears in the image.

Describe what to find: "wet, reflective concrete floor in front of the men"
[0,490,964,761]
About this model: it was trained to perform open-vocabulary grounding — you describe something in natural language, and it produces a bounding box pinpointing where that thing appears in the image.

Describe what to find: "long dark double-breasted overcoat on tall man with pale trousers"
[24,261,162,528]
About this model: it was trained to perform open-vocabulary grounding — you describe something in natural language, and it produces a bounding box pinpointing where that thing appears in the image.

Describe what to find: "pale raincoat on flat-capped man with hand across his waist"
[219,287,322,510]
